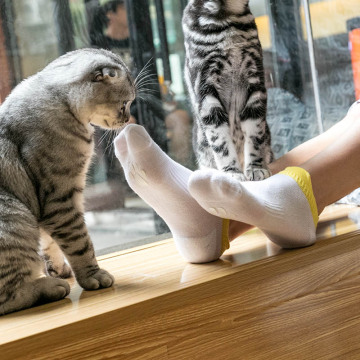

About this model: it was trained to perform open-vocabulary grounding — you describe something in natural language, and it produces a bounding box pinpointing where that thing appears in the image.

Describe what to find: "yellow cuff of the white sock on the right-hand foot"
[279,166,319,227]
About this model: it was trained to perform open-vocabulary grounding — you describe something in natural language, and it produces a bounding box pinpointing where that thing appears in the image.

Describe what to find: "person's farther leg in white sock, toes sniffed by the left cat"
[116,103,357,262]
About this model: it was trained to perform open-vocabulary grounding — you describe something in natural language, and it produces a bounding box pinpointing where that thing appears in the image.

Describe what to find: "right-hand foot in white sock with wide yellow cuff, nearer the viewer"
[189,167,318,248]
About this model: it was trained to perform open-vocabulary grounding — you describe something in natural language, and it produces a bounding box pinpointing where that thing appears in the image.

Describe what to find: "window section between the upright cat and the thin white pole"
[250,0,319,158]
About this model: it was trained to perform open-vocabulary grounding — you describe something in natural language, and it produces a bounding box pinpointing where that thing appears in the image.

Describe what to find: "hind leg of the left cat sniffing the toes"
[0,193,70,315]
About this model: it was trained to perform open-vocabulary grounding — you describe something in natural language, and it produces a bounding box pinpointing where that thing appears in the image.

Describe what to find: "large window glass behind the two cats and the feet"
[0,0,360,254]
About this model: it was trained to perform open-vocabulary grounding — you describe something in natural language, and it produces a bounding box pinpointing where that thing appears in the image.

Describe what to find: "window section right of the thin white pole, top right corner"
[301,0,360,129]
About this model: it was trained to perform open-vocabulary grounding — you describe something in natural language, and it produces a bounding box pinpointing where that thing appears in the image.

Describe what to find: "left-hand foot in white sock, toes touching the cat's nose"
[115,125,228,263]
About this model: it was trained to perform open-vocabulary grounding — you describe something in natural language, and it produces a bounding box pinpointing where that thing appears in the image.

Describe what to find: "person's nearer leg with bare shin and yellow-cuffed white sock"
[189,101,360,247]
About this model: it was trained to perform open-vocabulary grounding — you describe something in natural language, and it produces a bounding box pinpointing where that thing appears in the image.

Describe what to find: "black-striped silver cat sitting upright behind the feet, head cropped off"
[183,0,273,181]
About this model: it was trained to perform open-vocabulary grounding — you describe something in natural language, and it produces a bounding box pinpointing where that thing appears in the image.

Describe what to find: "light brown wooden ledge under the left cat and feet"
[0,206,360,360]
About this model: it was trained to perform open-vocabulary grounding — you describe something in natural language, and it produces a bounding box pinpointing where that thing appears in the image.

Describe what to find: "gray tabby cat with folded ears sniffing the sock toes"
[0,49,135,314]
